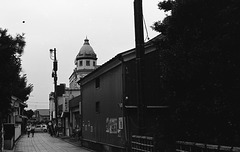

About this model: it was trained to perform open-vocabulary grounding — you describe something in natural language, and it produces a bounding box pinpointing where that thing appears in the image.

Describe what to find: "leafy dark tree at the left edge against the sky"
[0,28,33,119]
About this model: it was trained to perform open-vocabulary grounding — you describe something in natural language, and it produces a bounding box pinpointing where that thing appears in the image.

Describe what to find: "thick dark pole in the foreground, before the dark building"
[134,0,145,135]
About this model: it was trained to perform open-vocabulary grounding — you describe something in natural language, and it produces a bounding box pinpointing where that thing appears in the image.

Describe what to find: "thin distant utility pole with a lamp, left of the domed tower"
[50,48,58,130]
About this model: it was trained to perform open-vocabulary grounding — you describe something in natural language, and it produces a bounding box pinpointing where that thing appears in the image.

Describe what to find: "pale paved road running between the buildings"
[14,133,90,152]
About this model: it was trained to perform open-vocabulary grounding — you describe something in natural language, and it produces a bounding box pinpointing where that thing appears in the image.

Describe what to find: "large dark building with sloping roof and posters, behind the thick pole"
[80,35,168,151]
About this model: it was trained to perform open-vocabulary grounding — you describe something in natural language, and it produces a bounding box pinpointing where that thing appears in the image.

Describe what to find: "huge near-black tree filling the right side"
[152,0,240,146]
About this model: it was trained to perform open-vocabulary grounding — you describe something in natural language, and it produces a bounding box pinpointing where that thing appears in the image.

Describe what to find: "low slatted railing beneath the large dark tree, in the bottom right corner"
[176,141,240,152]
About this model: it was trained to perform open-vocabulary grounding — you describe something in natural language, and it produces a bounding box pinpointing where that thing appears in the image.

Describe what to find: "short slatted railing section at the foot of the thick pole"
[131,135,154,152]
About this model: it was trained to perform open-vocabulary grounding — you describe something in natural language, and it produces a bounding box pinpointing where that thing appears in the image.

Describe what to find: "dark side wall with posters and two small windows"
[82,66,125,147]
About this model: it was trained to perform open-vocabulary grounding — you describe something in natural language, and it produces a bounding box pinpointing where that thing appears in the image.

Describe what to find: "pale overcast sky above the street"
[0,0,166,110]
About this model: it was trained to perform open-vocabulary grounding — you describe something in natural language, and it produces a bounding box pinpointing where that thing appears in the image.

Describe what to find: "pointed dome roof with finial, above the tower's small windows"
[76,38,97,60]
